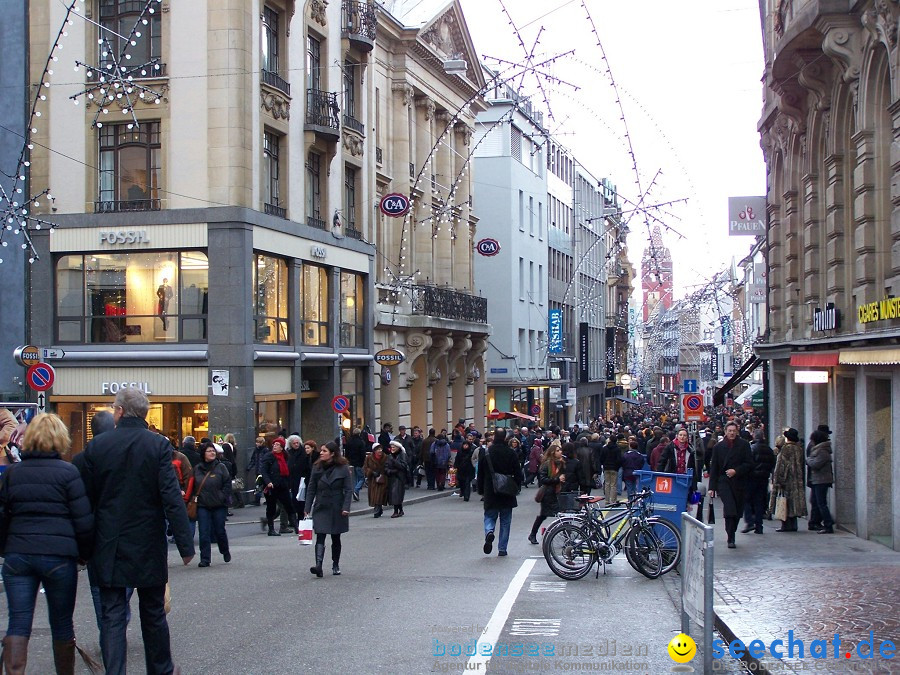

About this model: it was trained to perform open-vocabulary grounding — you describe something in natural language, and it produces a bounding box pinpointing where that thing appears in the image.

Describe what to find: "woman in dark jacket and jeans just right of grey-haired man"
[189,443,231,567]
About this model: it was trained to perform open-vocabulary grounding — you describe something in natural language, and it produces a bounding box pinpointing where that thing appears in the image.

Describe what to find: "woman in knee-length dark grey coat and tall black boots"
[306,442,353,577]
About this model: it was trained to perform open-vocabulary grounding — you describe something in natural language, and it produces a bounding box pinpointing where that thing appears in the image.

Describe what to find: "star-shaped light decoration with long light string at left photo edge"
[0,0,84,263]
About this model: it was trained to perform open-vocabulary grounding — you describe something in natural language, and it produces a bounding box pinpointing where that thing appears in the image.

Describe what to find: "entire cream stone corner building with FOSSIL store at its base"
[29,0,375,462]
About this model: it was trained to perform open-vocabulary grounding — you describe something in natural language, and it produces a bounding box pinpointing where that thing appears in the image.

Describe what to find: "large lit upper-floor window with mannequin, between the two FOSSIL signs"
[55,251,209,344]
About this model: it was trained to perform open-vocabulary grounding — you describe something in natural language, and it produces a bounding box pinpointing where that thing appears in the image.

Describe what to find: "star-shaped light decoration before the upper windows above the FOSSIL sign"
[69,0,163,129]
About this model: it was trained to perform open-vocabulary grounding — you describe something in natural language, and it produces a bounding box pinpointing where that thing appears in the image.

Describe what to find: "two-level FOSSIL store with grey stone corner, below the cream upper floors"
[30,217,373,460]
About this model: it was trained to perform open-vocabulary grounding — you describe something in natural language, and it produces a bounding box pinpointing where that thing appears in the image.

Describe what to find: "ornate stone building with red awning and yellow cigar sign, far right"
[756,0,900,549]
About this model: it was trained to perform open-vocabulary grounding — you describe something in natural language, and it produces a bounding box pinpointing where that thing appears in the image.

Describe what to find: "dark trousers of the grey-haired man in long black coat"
[100,584,174,675]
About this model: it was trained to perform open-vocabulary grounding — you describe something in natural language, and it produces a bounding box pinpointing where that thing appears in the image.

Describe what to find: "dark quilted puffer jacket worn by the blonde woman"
[0,452,94,560]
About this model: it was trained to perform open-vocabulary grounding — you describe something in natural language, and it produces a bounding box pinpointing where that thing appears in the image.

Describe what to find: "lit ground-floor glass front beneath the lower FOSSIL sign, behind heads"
[56,400,209,455]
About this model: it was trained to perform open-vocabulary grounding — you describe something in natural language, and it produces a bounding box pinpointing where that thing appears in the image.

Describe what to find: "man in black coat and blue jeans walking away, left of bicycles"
[477,429,523,556]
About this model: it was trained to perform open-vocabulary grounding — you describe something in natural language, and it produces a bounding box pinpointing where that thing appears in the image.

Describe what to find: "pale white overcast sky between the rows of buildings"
[461,0,765,298]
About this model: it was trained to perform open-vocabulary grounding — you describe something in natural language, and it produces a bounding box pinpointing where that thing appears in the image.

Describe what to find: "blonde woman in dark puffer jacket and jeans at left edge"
[0,415,94,673]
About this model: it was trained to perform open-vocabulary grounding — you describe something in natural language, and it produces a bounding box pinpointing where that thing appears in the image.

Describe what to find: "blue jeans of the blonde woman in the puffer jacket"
[3,553,78,640]
